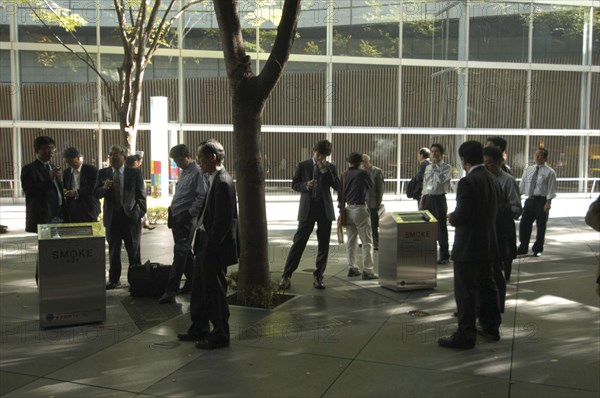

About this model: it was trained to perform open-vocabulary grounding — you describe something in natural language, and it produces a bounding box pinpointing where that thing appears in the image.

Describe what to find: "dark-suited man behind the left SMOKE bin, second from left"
[63,147,100,222]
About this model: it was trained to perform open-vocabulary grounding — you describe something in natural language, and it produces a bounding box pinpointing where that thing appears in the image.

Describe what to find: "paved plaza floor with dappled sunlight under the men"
[0,197,600,398]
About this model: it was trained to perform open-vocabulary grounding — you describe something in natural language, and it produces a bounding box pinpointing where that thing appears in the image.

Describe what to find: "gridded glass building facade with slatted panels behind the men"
[0,0,600,194]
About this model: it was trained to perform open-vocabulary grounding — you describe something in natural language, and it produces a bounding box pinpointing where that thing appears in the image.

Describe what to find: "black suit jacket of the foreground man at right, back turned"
[448,166,502,263]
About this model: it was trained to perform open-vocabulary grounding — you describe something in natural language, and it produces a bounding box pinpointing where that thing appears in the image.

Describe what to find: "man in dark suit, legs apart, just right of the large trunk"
[279,140,340,289]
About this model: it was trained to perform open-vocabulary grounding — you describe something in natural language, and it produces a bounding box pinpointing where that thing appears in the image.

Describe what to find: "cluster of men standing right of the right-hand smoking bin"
[415,137,556,348]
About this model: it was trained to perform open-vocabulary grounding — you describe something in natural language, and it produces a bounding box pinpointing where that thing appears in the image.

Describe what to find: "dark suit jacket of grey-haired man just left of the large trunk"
[200,167,239,267]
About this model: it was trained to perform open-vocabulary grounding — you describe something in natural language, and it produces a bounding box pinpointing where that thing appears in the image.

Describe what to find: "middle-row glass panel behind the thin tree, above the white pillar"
[101,54,179,122]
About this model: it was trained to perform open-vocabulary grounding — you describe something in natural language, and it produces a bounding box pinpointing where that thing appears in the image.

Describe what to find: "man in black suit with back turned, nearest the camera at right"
[438,141,502,349]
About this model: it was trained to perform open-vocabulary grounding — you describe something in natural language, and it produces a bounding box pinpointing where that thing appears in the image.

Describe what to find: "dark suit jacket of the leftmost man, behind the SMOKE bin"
[21,159,65,233]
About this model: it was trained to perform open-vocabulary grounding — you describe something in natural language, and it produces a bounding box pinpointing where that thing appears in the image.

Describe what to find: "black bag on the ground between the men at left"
[127,260,171,298]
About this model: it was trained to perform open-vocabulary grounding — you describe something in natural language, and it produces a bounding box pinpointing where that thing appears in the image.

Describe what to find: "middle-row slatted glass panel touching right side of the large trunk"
[263,62,327,126]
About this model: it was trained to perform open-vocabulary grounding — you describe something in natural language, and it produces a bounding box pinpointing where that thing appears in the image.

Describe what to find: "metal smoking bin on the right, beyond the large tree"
[379,210,438,291]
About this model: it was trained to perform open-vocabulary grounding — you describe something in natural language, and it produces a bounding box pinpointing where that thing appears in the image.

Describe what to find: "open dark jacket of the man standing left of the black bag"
[94,167,146,228]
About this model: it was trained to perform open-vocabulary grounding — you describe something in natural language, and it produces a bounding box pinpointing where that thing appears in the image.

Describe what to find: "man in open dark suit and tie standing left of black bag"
[94,145,146,290]
